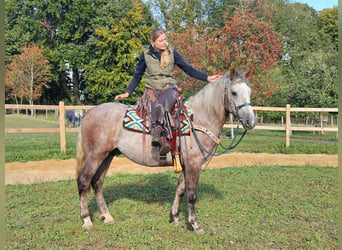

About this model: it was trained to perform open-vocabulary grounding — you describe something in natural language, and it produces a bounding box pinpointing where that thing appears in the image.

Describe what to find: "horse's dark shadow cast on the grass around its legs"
[89,173,222,216]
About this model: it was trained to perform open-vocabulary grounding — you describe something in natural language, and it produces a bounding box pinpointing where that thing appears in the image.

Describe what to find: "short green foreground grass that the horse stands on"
[5,166,338,249]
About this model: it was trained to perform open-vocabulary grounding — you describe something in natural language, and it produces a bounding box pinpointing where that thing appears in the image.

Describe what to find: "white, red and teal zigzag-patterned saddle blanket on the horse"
[123,104,192,134]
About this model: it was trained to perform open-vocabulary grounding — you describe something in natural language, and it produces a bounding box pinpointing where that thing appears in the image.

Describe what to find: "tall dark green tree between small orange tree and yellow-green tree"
[36,0,100,103]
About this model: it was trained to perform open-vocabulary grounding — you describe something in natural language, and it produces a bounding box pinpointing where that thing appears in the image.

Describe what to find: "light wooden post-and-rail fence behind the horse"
[5,102,338,153]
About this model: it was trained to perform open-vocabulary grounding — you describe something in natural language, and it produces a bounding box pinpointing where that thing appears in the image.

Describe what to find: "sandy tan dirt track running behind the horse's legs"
[5,153,338,184]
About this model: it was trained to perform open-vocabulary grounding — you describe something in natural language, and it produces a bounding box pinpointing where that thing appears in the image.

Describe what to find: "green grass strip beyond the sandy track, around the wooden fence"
[5,115,337,163]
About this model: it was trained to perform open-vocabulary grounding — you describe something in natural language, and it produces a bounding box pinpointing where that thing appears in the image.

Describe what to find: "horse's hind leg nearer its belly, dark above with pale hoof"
[91,152,115,224]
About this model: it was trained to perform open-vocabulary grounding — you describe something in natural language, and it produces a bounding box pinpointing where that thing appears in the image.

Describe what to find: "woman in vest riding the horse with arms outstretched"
[115,29,220,156]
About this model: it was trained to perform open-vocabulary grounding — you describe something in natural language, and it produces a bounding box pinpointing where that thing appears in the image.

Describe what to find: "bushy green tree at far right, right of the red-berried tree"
[272,0,337,107]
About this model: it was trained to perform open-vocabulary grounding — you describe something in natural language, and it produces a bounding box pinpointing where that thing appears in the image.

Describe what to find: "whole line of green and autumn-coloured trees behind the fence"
[5,0,338,107]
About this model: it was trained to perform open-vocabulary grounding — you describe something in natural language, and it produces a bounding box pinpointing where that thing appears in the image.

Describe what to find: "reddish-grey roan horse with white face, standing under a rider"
[77,69,256,234]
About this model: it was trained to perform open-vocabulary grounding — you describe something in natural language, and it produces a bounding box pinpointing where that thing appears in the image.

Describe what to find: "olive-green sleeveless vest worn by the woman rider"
[144,48,176,90]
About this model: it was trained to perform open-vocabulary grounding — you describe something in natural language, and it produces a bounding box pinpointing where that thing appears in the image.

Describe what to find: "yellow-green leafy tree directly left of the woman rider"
[84,2,151,103]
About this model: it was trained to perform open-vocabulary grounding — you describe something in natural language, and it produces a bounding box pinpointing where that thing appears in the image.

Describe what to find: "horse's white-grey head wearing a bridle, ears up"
[225,69,256,129]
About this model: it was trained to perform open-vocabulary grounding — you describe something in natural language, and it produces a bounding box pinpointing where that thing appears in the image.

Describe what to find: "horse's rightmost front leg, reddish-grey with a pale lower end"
[185,165,204,234]
